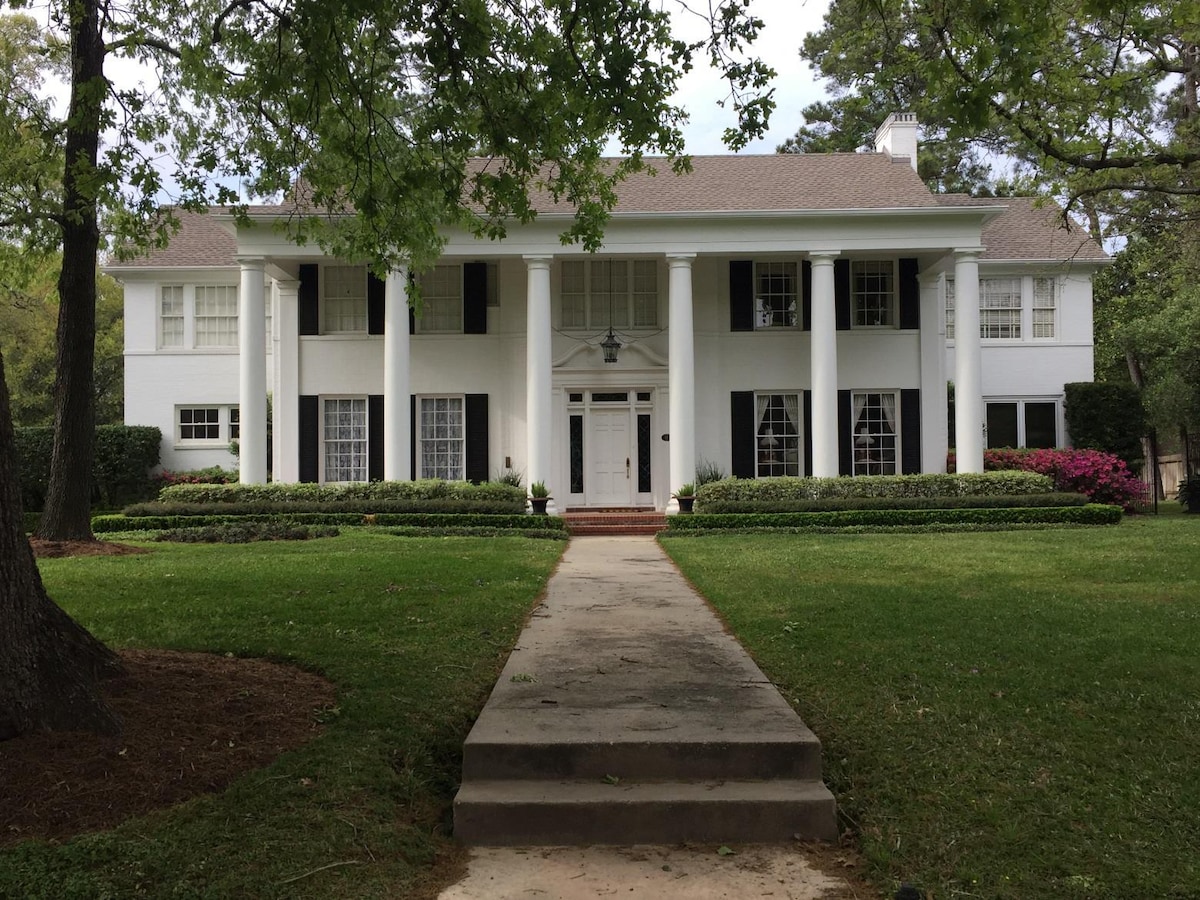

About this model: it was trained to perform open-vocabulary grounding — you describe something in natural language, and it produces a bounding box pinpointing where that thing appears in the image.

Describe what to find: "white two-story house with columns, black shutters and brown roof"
[109,114,1105,509]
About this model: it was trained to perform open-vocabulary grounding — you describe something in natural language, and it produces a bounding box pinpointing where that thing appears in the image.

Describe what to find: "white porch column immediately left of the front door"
[524,257,552,494]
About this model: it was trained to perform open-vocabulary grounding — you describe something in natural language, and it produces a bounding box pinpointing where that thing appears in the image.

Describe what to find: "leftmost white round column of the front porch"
[238,258,266,485]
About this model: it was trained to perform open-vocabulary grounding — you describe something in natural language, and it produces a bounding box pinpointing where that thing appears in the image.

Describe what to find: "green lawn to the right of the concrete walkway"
[662,516,1200,900]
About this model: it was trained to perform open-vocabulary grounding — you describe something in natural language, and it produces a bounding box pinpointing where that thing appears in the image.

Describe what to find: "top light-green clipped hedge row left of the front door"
[158,479,526,509]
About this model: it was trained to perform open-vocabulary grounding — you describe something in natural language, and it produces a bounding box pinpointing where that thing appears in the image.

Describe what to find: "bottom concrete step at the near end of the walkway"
[454,779,838,846]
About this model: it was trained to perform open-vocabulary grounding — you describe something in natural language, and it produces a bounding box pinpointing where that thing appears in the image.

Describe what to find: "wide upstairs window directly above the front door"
[559,259,659,329]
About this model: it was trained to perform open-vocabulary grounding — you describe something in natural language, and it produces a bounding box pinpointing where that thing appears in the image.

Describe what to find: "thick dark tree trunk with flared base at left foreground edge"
[0,348,120,740]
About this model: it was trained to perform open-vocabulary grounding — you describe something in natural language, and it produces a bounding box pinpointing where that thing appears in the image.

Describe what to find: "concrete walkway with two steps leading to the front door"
[455,536,836,846]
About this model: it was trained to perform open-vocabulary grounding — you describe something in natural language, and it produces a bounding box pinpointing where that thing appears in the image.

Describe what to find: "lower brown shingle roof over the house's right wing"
[937,193,1109,260]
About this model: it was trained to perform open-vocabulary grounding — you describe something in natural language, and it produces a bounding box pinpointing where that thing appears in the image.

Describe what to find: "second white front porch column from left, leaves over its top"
[383,265,413,481]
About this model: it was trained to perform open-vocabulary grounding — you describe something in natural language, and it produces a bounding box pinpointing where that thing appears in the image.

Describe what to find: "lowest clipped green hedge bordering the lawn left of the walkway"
[91,512,566,534]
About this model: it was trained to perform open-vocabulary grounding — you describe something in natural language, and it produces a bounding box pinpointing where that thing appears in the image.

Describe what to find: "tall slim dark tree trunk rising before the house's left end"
[37,0,107,540]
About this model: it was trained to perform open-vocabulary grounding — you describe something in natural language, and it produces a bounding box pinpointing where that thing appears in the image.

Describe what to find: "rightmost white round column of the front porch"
[954,250,983,472]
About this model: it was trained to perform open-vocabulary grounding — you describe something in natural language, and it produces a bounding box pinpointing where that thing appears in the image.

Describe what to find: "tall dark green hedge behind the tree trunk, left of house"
[13,425,162,511]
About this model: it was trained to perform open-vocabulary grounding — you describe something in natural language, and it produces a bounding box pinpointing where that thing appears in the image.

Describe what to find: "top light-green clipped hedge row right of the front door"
[696,472,1054,511]
